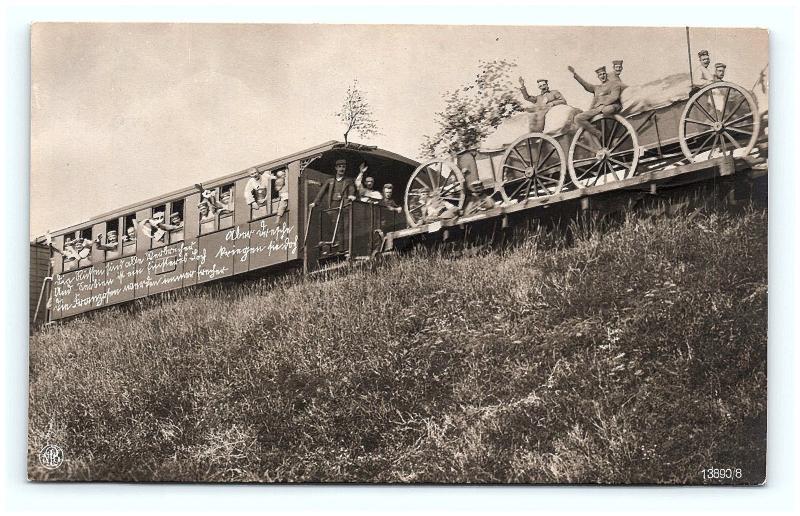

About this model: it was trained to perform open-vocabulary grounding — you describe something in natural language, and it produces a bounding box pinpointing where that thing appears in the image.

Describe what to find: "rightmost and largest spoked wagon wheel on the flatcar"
[678,82,761,161]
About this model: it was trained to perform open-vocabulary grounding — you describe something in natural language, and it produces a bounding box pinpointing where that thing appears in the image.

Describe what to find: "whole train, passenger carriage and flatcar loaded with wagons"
[30,70,767,324]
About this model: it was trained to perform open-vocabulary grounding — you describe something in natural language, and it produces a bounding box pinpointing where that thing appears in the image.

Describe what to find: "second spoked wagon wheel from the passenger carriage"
[498,133,567,202]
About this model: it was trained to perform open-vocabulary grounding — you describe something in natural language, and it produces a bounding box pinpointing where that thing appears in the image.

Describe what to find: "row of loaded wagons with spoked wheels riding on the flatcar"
[404,78,761,226]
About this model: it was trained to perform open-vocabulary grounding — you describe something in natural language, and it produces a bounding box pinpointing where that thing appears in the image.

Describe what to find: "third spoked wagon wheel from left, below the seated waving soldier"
[567,115,639,188]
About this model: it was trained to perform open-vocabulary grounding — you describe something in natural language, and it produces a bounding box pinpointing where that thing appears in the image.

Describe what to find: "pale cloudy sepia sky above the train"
[30,23,768,236]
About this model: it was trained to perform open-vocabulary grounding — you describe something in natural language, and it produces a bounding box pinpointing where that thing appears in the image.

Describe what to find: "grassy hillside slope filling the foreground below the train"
[29,201,767,483]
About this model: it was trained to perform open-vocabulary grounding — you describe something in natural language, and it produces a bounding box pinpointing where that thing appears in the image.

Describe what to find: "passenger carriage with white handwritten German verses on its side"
[31,141,419,321]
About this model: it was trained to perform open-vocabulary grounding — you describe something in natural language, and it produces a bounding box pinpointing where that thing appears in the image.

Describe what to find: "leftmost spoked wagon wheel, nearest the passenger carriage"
[403,159,466,226]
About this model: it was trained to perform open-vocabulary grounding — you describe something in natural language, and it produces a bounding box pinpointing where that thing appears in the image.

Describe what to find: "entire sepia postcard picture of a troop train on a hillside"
[28,23,769,485]
